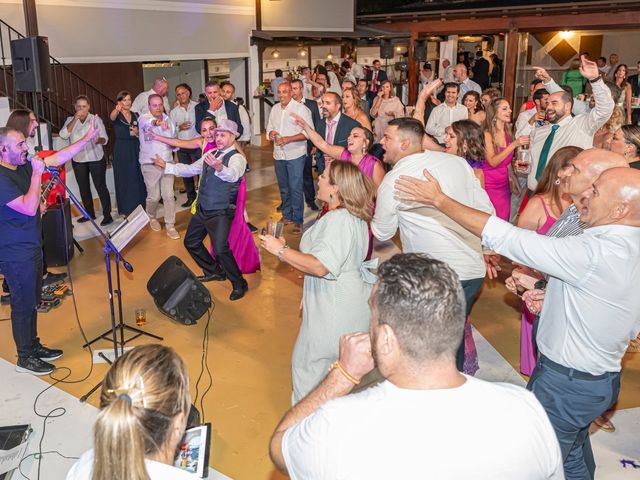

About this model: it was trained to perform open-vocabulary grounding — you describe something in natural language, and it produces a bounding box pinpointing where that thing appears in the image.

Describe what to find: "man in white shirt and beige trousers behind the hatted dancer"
[138,94,180,240]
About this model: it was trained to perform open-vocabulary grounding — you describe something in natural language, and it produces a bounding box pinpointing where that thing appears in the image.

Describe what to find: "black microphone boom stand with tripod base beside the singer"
[47,167,164,402]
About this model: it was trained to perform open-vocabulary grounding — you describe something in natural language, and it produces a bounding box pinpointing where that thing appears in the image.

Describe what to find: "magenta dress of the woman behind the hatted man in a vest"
[202,143,260,273]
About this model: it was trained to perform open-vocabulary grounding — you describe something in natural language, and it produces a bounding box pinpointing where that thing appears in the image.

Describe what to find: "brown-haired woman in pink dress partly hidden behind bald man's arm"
[507,147,582,376]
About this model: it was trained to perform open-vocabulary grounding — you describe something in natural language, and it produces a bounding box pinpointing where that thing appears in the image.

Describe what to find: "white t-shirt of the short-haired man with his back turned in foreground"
[282,377,564,480]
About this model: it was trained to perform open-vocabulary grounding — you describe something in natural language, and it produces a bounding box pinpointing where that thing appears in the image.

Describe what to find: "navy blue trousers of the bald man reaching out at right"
[527,355,620,480]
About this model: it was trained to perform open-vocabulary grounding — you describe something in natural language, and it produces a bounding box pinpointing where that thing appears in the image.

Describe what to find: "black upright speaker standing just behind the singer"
[42,198,74,267]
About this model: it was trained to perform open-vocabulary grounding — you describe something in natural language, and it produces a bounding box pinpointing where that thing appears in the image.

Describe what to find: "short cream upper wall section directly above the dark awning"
[260,0,355,32]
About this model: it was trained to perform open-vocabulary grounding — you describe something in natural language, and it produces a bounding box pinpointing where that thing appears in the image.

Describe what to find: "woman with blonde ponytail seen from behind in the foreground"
[67,345,193,480]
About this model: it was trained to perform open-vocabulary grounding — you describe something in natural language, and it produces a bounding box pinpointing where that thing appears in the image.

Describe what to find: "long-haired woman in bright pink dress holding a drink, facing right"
[484,98,530,221]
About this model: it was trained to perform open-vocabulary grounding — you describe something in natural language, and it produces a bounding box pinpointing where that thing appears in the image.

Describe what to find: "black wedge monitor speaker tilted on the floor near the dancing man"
[147,256,211,325]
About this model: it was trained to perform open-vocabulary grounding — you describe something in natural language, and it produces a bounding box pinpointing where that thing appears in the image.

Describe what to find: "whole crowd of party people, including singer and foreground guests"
[0,43,640,479]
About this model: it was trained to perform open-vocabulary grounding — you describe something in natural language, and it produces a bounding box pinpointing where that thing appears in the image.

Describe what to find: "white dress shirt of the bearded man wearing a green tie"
[527,80,615,190]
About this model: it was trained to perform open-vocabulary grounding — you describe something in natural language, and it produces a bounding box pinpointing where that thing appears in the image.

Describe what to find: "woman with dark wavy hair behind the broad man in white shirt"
[444,120,485,188]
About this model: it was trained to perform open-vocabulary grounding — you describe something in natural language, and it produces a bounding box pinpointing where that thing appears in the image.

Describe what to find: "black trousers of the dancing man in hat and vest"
[184,206,243,288]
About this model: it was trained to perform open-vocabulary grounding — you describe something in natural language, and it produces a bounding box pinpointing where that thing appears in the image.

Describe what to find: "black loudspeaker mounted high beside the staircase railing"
[11,37,51,93]
